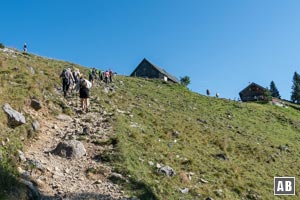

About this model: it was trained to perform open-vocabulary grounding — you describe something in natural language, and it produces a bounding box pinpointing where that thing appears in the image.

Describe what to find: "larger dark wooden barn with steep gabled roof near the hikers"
[130,58,180,83]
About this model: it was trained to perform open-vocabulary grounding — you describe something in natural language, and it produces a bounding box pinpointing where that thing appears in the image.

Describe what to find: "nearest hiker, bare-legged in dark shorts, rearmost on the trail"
[79,75,92,112]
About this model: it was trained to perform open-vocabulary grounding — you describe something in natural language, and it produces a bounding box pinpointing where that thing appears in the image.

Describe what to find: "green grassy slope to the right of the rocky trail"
[94,77,300,199]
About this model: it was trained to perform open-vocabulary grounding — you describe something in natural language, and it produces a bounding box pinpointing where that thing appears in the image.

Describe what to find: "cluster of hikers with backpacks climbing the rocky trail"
[60,68,113,112]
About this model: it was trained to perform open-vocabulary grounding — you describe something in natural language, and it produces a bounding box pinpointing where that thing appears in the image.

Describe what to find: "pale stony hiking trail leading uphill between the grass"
[19,87,127,199]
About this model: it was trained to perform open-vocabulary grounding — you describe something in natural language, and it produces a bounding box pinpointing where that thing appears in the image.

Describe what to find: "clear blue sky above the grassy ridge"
[0,0,300,99]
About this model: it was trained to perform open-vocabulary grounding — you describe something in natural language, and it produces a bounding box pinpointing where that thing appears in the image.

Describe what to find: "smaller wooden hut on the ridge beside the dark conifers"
[239,83,268,102]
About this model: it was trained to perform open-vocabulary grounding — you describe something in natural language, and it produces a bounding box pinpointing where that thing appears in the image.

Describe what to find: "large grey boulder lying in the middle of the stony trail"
[51,140,86,159]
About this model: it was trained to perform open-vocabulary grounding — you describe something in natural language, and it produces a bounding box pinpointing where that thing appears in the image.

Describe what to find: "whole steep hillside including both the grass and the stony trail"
[0,49,300,199]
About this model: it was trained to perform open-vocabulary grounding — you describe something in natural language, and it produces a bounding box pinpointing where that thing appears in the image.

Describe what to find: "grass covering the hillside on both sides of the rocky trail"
[0,47,300,199]
